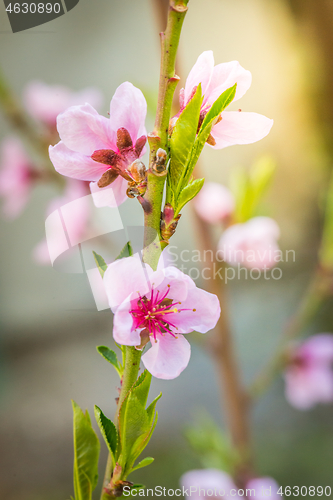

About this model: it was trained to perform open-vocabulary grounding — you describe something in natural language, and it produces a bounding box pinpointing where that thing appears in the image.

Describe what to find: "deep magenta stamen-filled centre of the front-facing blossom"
[130,285,195,341]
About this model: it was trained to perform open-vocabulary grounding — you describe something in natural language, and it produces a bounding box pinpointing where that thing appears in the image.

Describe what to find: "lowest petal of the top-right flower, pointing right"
[211,111,273,149]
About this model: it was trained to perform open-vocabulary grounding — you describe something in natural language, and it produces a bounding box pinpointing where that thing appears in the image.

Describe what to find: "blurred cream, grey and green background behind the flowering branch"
[0,0,333,500]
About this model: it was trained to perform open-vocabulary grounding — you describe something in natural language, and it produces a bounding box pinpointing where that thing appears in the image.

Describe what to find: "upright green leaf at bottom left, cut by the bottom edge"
[72,401,100,500]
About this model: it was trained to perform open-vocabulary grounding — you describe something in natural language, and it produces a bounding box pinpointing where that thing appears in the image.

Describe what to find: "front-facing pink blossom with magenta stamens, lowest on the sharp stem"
[104,254,220,379]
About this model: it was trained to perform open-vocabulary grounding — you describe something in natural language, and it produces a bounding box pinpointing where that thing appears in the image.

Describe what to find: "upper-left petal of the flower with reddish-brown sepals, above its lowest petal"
[57,104,110,156]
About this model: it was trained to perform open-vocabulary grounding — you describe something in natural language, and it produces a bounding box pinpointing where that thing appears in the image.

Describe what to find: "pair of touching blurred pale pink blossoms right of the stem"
[194,182,280,269]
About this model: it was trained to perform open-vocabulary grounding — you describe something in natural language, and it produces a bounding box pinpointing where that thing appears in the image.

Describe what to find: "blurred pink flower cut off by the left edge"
[0,136,33,219]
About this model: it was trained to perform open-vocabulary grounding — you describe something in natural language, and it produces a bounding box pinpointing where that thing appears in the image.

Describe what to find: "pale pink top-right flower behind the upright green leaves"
[179,50,273,149]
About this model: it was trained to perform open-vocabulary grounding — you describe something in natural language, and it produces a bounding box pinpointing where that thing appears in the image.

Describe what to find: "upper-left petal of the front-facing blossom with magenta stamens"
[103,256,149,310]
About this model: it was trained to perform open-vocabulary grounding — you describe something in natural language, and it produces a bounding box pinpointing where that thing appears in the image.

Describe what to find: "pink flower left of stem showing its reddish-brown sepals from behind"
[49,82,147,205]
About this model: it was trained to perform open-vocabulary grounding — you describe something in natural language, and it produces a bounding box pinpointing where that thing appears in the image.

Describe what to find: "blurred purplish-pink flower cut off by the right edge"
[284,333,333,410]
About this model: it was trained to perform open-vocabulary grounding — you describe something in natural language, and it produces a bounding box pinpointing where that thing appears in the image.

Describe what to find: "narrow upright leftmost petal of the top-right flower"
[184,50,214,104]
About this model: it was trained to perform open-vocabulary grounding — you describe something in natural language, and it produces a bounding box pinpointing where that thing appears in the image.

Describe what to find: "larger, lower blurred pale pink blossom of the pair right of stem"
[218,217,280,269]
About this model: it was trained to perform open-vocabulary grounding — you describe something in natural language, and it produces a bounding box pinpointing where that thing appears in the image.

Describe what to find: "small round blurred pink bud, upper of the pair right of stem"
[194,182,235,224]
